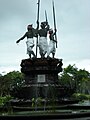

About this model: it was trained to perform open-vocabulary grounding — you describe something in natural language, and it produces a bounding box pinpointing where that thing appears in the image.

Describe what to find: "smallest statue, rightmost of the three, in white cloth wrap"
[47,29,57,58]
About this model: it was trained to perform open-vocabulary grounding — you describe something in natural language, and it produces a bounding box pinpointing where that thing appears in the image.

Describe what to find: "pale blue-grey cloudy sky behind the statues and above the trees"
[0,0,90,74]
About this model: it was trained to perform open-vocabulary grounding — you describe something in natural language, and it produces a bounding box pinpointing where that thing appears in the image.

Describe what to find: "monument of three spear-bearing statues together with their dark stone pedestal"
[11,0,64,107]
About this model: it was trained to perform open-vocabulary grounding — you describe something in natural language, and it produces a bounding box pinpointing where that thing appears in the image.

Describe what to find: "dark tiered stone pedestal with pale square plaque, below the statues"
[19,58,62,99]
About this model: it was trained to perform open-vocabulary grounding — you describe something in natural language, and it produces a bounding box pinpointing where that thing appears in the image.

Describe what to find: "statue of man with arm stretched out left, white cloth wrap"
[16,24,37,58]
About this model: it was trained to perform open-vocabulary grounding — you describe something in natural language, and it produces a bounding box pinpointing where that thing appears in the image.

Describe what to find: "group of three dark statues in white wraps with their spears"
[16,0,57,58]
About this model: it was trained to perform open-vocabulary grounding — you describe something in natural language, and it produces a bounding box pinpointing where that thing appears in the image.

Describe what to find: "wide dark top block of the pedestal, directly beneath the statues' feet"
[21,58,63,74]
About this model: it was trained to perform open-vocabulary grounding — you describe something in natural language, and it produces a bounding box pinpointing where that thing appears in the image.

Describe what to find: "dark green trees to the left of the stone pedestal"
[0,71,24,96]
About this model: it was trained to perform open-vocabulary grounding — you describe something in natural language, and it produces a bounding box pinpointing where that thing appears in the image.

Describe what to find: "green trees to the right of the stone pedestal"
[59,64,90,94]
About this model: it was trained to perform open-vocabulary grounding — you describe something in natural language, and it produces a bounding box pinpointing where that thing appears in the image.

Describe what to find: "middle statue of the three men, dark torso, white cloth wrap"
[38,22,49,58]
